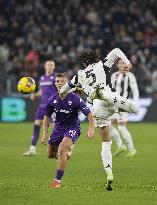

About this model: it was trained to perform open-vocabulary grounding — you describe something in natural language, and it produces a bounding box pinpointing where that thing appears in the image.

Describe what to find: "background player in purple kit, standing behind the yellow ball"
[23,60,57,156]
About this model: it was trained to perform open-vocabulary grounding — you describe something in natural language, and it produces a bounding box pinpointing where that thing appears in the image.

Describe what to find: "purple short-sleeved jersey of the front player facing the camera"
[46,93,91,129]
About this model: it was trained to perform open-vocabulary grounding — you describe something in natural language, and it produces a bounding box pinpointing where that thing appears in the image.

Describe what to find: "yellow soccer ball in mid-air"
[17,77,36,94]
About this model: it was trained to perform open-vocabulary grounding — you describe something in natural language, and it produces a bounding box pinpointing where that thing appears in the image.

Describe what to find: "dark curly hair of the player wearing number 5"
[78,49,100,66]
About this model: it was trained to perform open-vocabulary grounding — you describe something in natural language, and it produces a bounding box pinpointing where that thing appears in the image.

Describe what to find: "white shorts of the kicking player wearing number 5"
[92,99,116,127]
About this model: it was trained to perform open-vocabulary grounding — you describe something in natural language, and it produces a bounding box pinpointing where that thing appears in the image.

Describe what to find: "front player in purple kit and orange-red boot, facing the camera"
[42,73,94,188]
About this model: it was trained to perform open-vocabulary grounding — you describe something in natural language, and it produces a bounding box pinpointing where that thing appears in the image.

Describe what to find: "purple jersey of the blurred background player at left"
[40,74,57,105]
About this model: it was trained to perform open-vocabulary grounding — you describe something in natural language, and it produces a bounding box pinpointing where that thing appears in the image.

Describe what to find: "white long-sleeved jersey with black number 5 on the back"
[60,48,130,97]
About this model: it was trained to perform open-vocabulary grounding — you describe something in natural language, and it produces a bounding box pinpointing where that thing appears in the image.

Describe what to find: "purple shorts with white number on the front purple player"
[48,127,81,146]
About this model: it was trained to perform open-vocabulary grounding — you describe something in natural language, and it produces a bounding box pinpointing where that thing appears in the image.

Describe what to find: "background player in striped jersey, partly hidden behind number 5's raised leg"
[110,59,139,157]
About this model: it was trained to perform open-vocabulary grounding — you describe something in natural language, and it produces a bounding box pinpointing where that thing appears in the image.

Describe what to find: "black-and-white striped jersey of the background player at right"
[111,71,139,104]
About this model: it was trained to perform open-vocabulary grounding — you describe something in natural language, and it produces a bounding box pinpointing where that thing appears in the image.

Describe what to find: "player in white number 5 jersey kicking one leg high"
[60,48,137,190]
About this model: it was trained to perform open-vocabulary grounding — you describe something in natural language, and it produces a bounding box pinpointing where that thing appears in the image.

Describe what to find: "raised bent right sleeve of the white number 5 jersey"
[104,48,130,68]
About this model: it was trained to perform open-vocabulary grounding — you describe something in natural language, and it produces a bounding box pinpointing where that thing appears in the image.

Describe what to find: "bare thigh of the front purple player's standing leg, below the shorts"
[58,136,73,152]
